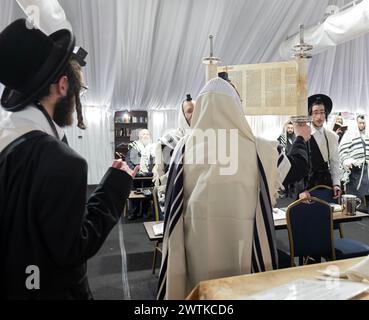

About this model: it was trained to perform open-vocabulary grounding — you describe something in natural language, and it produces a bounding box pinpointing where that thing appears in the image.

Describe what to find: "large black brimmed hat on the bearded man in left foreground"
[0,19,75,112]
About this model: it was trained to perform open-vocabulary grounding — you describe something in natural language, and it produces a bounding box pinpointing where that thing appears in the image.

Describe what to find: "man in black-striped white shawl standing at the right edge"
[339,115,369,211]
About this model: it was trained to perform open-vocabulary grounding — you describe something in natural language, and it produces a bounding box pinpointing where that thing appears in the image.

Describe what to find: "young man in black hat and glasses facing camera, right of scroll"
[302,94,341,199]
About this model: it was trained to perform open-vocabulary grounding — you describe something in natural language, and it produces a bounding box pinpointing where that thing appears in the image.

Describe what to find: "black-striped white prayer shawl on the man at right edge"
[339,126,369,190]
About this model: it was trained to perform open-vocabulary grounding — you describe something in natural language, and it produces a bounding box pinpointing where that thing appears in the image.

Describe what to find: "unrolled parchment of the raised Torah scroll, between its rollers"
[218,60,308,116]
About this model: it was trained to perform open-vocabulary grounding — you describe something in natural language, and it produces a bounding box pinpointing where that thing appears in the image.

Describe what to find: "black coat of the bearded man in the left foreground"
[0,131,132,299]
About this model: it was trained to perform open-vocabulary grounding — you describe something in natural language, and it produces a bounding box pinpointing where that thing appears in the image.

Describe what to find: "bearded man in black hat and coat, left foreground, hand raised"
[0,19,139,299]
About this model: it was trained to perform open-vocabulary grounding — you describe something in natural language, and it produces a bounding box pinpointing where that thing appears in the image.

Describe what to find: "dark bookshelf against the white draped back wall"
[114,111,148,159]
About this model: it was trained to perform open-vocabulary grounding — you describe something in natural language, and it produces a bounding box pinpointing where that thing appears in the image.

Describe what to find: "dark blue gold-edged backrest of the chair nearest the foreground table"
[286,197,336,266]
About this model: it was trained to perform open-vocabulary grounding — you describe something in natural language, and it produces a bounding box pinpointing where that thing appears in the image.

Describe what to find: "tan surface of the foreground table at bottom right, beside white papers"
[187,257,369,300]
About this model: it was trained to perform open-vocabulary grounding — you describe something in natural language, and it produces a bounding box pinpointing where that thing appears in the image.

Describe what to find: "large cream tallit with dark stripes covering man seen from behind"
[158,78,282,299]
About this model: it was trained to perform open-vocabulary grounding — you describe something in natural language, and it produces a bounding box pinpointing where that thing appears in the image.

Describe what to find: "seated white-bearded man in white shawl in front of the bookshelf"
[126,129,154,220]
